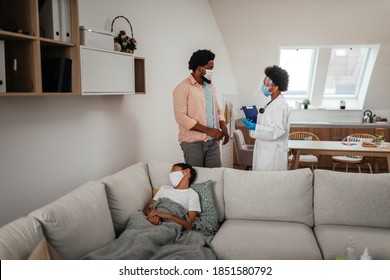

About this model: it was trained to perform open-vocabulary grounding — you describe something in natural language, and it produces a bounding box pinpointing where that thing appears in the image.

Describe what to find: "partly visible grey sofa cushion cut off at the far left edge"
[0,217,44,260]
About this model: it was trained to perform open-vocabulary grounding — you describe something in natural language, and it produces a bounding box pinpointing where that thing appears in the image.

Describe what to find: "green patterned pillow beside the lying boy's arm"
[190,180,219,230]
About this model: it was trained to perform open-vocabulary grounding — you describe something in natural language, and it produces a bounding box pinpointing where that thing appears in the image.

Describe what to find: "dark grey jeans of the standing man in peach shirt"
[180,140,222,167]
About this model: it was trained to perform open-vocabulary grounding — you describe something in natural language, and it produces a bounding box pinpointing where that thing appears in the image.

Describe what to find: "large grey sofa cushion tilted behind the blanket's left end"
[30,182,115,259]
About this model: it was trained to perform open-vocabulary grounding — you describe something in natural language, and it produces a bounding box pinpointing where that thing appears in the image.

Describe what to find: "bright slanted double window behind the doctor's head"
[279,45,379,109]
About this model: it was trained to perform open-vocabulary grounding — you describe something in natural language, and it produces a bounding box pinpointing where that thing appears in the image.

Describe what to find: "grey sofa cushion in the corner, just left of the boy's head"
[100,162,152,236]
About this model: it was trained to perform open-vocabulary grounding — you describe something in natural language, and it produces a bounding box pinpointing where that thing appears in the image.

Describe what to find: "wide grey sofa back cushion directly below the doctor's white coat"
[224,168,313,226]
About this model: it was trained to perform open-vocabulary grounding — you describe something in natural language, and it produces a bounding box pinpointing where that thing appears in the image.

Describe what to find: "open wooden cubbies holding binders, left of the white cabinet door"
[0,0,81,97]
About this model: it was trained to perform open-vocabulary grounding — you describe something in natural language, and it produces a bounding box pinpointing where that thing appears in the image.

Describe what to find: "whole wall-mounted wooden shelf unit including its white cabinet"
[0,0,146,97]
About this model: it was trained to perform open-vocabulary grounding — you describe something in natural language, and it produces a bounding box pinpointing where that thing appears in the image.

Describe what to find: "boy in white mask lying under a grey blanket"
[84,163,216,260]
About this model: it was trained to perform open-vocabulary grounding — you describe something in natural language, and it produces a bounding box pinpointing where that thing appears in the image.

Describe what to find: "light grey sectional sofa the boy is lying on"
[0,161,390,260]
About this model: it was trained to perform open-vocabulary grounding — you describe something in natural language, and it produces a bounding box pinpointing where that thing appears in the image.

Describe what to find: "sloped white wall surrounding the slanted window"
[209,0,390,119]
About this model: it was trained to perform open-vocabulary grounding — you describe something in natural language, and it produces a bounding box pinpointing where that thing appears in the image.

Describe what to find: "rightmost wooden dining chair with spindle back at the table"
[332,133,376,173]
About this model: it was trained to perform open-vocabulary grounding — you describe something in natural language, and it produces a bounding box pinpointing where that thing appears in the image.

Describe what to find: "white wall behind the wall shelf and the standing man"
[0,0,237,226]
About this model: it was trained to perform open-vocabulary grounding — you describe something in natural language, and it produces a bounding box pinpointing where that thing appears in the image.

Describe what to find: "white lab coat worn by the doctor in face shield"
[250,95,290,170]
